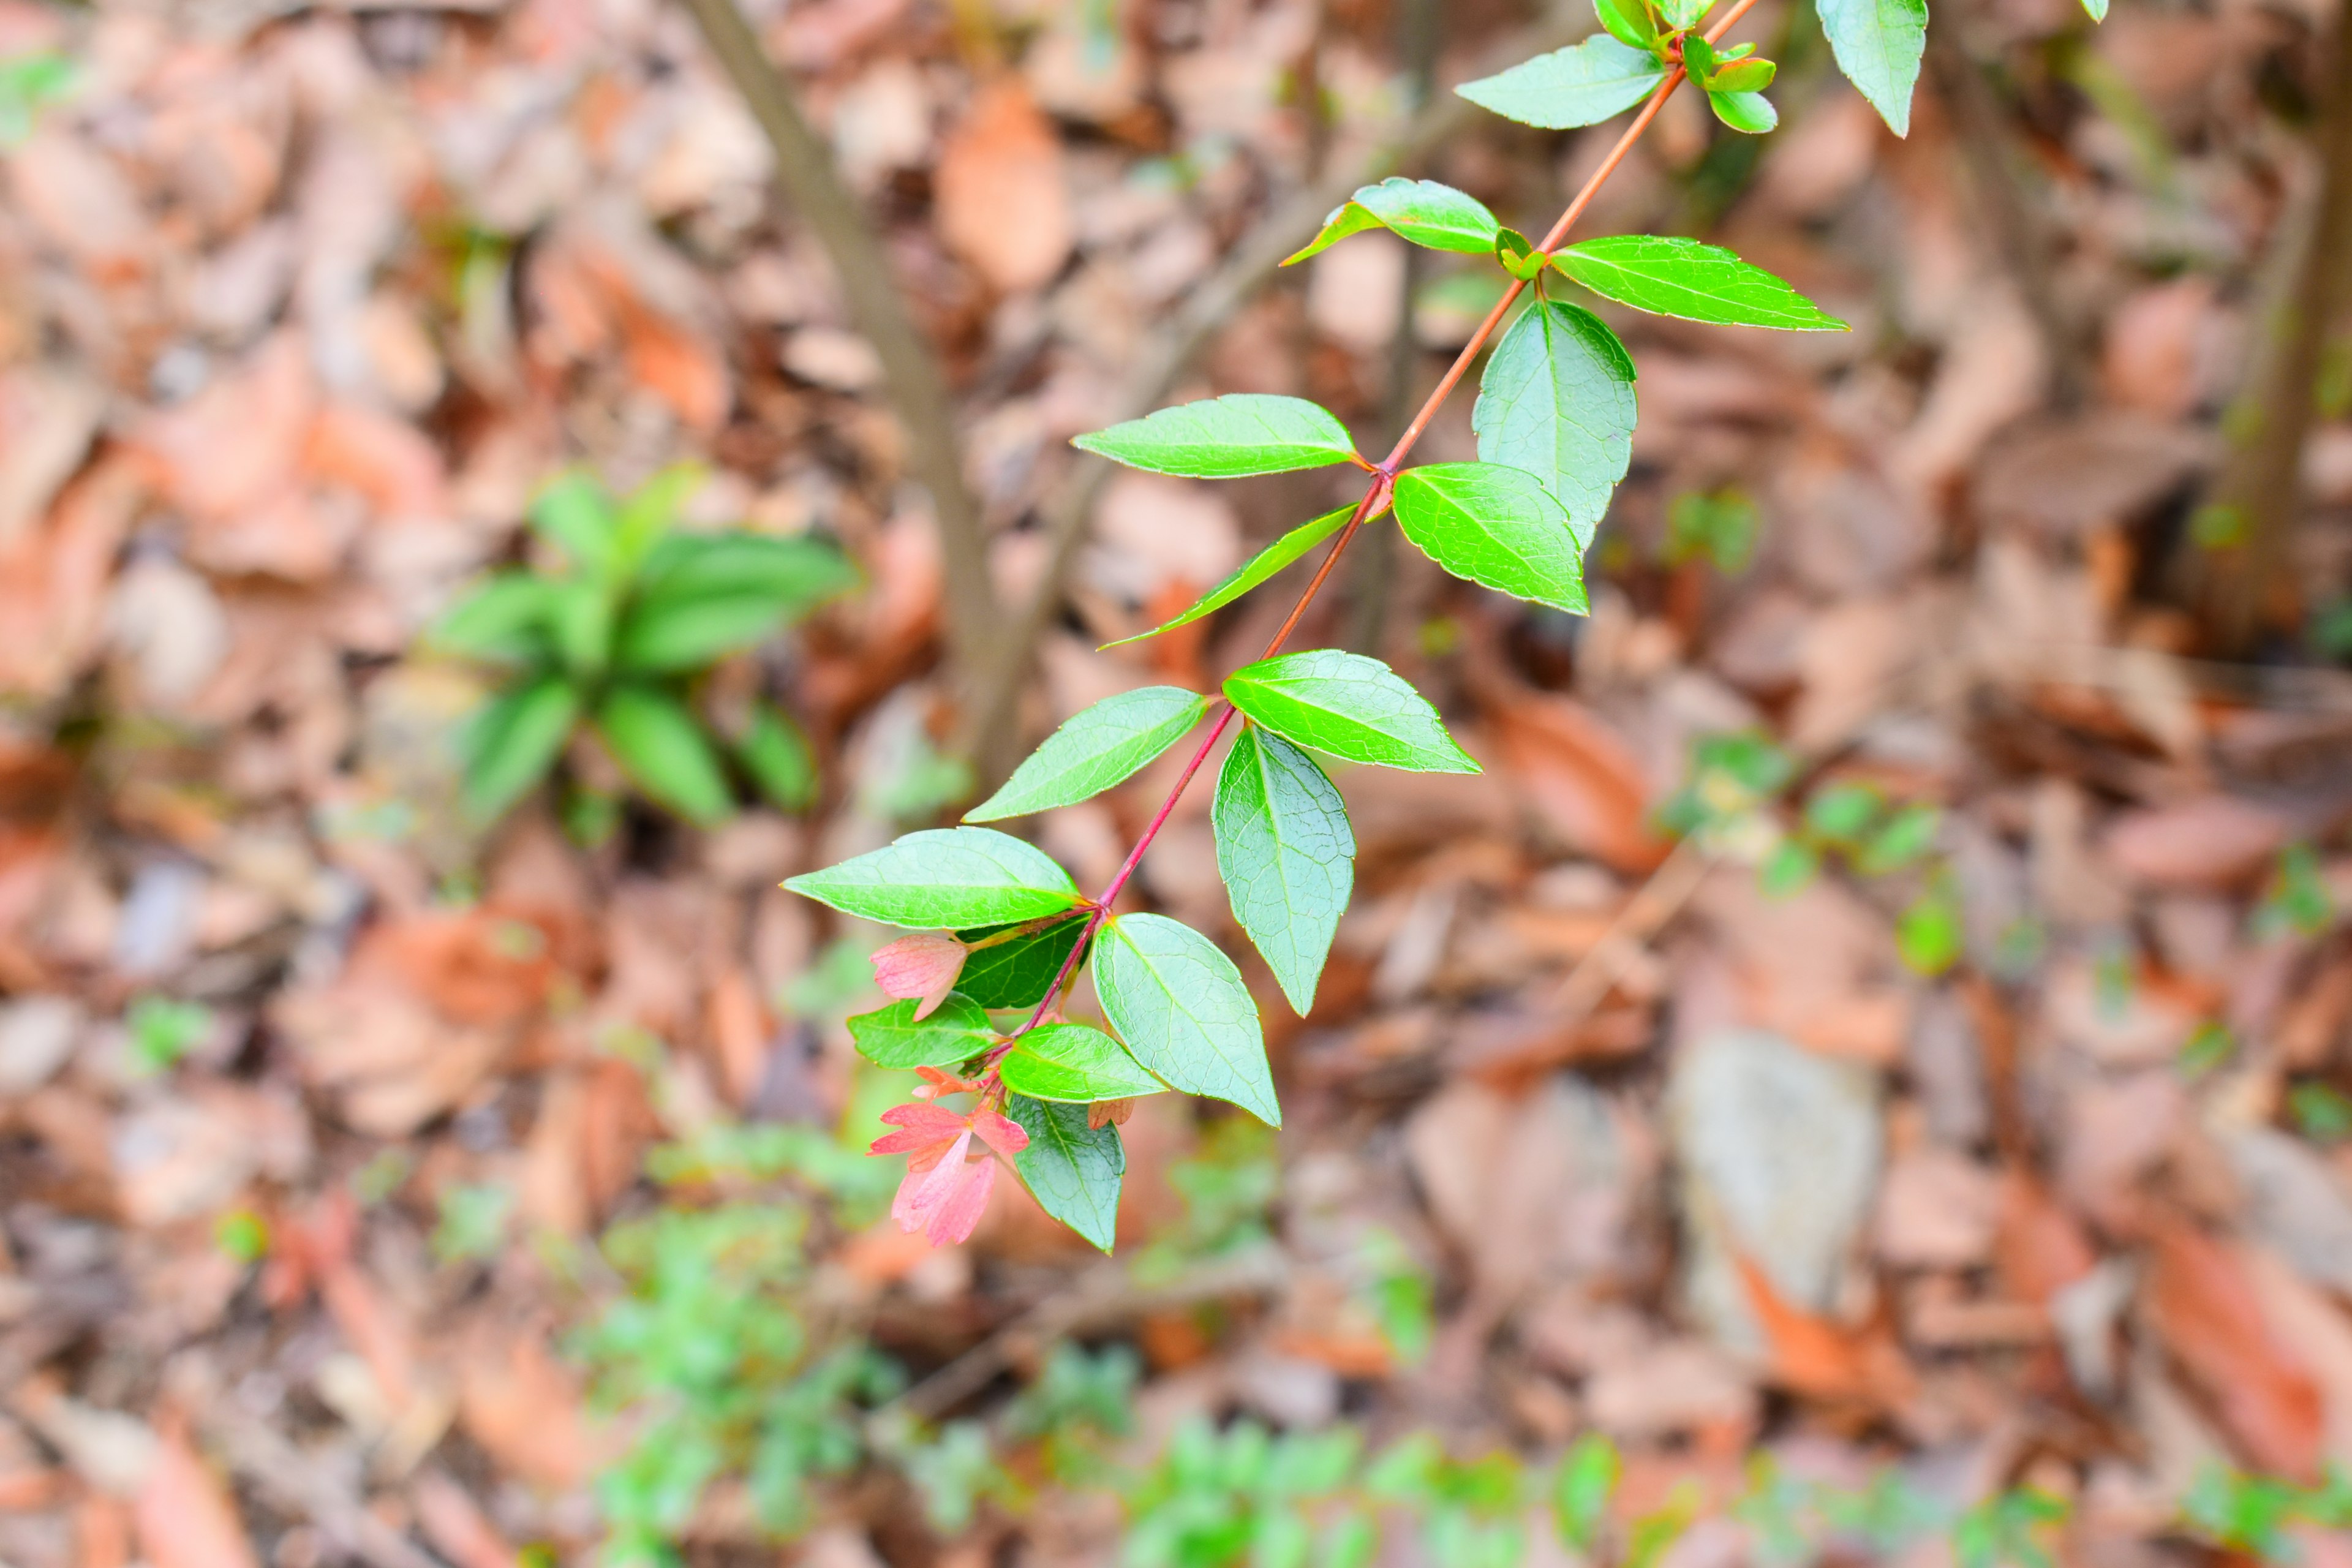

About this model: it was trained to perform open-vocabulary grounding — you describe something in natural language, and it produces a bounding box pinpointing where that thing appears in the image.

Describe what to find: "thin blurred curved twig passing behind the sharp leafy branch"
[960,6,1580,785]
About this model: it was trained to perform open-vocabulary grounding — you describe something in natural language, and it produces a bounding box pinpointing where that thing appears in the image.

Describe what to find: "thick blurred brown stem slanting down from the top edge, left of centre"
[682,0,1002,689]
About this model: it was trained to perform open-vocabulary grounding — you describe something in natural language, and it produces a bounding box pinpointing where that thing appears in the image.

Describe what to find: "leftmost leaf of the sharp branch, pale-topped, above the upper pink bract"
[783,827,1080,931]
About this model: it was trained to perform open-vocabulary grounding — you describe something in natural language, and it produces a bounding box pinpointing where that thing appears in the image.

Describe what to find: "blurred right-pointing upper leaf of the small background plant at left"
[614,533,859,673]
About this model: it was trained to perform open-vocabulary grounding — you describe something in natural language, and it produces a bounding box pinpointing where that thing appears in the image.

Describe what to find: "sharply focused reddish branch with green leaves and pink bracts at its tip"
[786,0,2117,1251]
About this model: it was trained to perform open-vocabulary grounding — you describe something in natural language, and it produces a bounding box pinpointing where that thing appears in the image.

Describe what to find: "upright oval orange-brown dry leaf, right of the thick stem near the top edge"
[932,75,1075,294]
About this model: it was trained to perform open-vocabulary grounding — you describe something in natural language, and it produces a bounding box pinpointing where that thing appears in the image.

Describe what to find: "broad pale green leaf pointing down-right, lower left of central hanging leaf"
[1094,914,1282,1126]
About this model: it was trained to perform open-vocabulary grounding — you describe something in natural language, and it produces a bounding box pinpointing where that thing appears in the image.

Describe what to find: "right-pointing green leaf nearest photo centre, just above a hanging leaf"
[1226,649,1479,774]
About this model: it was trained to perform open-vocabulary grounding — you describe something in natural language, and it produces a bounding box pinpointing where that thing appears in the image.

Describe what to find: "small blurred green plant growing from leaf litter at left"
[431,466,856,839]
